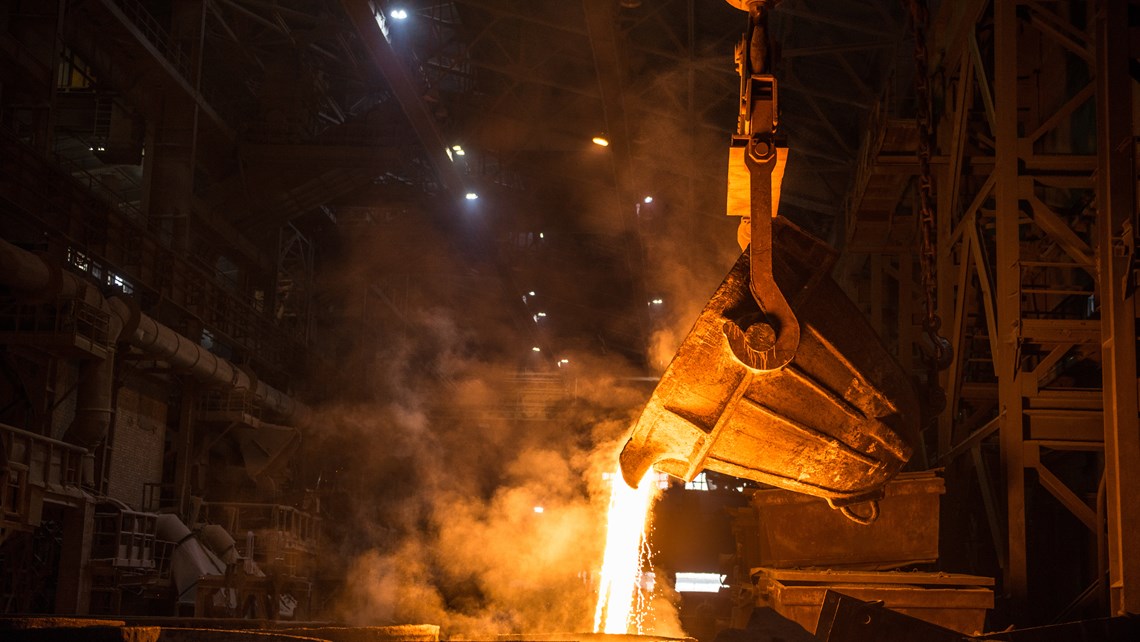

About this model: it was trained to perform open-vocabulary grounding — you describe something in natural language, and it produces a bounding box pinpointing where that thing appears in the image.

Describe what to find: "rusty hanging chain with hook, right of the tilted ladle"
[906,0,952,376]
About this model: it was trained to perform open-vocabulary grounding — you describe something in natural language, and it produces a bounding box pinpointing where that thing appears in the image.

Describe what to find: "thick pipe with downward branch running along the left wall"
[0,238,309,447]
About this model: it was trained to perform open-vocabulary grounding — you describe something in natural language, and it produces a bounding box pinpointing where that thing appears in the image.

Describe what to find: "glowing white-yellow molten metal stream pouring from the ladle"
[594,469,659,634]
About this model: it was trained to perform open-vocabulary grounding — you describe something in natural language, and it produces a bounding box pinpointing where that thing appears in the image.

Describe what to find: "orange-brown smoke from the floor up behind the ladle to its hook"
[307,33,740,639]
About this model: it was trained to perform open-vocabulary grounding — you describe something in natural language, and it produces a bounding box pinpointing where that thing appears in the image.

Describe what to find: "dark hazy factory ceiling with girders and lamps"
[31,0,913,369]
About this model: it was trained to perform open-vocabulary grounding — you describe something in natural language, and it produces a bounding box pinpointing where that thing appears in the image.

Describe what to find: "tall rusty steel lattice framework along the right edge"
[842,0,1140,617]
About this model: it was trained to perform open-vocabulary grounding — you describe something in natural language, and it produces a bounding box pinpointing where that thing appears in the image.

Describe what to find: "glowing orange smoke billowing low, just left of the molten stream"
[307,217,675,639]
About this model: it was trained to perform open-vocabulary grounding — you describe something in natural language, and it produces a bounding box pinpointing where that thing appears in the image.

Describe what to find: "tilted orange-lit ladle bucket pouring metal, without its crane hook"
[621,219,919,506]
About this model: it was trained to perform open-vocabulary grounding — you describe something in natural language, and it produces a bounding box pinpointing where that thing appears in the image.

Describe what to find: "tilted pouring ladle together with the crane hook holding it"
[621,0,919,522]
